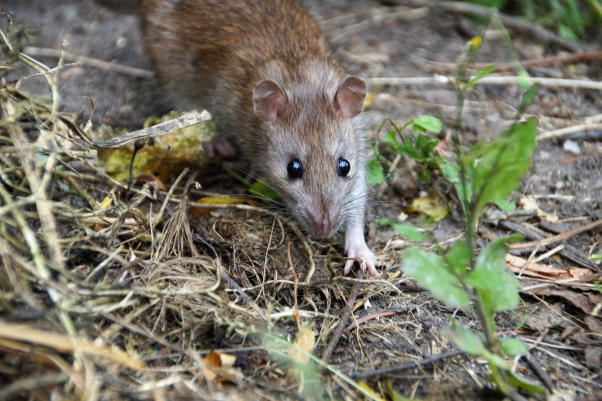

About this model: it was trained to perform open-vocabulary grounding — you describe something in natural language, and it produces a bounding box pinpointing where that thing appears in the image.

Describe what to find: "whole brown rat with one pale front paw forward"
[96,0,377,275]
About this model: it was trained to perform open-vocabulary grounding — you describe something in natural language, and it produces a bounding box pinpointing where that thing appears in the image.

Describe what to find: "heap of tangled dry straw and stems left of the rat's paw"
[0,17,412,399]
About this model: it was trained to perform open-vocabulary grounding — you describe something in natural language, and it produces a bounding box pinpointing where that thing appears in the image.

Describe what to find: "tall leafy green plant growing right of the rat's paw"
[370,38,545,394]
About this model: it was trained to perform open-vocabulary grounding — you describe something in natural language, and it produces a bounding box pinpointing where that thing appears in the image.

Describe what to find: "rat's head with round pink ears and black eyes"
[253,76,366,238]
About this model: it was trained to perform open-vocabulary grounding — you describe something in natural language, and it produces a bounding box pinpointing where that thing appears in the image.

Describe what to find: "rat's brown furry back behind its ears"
[138,0,338,125]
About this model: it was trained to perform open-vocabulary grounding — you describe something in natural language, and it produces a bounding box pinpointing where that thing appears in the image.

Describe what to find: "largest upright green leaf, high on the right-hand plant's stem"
[462,119,537,220]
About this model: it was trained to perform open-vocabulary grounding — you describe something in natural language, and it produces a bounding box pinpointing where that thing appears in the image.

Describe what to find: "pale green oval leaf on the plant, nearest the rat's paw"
[401,248,470,306]
